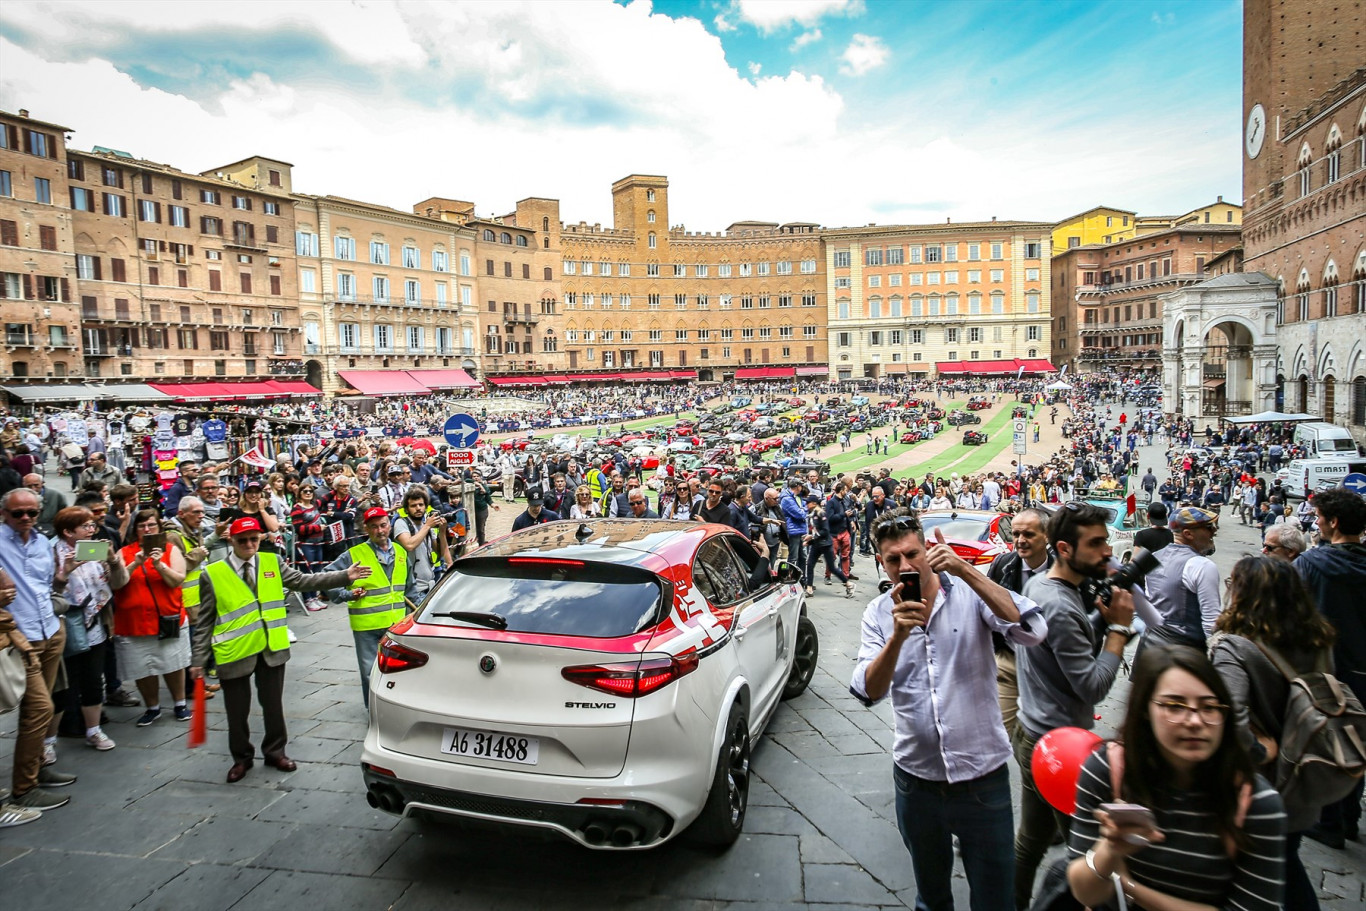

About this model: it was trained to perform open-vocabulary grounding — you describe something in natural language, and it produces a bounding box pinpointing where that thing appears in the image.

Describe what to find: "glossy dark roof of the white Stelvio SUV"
[475,519,724,572]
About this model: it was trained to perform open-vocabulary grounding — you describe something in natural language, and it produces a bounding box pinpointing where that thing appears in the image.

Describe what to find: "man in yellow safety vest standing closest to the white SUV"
[328,507,417,707]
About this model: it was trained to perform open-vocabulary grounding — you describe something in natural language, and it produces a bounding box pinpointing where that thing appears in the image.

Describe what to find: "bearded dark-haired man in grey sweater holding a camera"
[1011,504,1134,910]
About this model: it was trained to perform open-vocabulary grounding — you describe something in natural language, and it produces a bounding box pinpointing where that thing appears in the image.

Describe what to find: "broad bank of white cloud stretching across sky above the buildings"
[0,0,1240,231]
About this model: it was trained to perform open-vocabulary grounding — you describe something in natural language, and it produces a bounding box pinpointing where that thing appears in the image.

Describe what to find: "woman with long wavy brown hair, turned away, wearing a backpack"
[1210,557,1337,911]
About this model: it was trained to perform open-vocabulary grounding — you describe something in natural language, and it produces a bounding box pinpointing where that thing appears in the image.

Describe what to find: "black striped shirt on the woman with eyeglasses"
[1067,750,1285,911]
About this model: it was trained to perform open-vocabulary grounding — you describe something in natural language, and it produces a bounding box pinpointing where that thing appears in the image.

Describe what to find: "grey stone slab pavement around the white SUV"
[0,410,1366,911]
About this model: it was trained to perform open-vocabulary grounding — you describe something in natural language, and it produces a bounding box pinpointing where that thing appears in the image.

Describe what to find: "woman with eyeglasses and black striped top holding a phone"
[1067,645,1285,911]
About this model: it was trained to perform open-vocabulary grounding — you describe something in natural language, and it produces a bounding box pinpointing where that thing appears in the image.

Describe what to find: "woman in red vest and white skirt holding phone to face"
[113,509,191,728]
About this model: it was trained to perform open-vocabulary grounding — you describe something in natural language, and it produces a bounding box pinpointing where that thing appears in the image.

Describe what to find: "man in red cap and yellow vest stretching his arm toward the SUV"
[190,516,370,783]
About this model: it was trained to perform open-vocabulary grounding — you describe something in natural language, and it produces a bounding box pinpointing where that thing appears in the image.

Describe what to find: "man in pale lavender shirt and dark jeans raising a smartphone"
[850,509,1048,911]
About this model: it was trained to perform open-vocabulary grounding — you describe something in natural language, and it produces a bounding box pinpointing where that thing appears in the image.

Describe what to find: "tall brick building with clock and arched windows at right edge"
[1243,0,1366,441]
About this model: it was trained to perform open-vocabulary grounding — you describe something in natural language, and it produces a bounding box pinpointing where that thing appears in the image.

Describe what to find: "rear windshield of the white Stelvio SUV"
[418,557,663,639]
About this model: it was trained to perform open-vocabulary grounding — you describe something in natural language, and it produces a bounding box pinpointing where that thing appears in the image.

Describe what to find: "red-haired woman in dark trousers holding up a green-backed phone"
[52,507,128,751]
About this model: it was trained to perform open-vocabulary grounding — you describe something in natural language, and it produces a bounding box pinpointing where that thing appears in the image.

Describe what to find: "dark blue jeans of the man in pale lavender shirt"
[893,765,1015,911]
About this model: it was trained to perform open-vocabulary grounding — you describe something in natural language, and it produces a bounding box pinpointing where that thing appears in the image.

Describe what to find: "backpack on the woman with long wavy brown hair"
[1257,642,1366,809]
